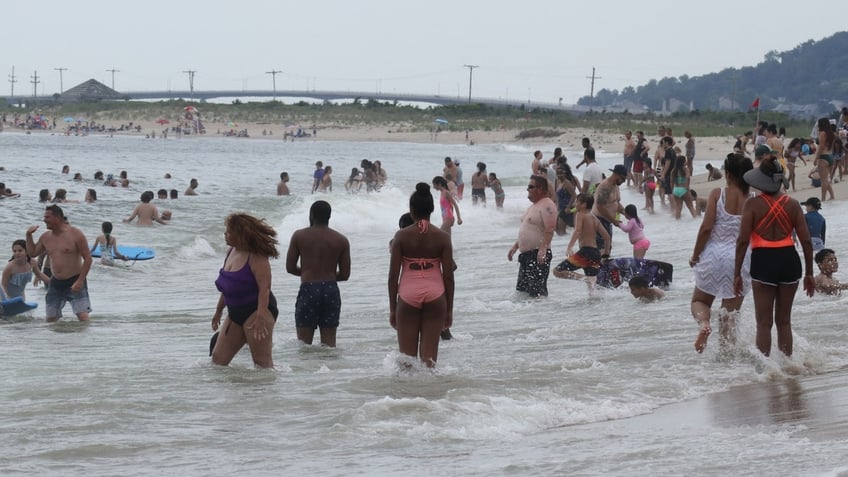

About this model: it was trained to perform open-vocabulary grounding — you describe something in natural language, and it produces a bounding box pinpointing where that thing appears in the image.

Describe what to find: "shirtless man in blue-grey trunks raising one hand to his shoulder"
[26,204,91,322]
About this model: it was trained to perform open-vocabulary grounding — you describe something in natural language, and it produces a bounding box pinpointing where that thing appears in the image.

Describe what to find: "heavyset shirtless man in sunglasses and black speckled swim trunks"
[506,175,557,298]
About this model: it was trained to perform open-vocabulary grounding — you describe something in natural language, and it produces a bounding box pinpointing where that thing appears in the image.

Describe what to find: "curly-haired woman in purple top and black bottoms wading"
[211,213,279,368]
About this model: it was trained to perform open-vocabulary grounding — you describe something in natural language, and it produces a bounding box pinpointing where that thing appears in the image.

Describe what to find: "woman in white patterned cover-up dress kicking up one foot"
[689,153,754,353]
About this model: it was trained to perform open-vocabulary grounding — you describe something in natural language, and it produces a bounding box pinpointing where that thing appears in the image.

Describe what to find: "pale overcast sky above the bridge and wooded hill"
[0,0,844,104]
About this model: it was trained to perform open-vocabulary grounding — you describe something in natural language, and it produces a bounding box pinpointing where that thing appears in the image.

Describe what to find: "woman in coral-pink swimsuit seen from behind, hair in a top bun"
[389,182,454,367]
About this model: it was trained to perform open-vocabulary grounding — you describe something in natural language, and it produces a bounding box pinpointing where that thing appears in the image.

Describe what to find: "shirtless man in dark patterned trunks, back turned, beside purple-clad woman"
[286,200,350,347]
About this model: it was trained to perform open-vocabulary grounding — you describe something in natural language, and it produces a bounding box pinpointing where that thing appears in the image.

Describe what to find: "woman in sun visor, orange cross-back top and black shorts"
[733,154,816,357]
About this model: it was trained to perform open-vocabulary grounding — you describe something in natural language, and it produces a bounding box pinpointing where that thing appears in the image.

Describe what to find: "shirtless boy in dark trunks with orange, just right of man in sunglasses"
[554,193,612,289]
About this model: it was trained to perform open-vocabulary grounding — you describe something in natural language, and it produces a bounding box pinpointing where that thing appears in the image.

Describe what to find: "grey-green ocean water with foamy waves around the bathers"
[0,132,848,476]
